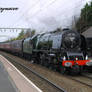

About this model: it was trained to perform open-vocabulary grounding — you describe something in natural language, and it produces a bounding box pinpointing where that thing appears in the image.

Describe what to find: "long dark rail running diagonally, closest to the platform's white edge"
[3,55,66,92]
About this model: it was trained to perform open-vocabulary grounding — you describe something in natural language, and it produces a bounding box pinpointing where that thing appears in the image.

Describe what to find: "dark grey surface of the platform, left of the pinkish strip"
[0,61,18,92]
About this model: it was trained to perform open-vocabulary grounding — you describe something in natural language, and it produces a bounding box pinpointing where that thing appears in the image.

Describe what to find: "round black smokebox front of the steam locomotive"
[62,30,81,50]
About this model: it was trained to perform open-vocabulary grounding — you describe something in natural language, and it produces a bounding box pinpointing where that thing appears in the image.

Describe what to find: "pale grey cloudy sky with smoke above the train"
[0,0,91,39]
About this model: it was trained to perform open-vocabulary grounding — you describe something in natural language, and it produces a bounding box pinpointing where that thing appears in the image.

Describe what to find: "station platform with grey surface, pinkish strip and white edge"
[0,55,42,92]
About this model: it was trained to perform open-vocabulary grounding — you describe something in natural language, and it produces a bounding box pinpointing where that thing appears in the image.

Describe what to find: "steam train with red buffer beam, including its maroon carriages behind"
[0,29,92,74]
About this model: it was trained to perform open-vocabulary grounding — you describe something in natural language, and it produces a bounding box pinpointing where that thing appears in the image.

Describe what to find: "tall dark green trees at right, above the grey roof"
[76,1,92,33]
